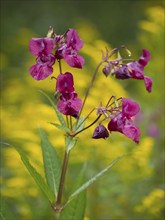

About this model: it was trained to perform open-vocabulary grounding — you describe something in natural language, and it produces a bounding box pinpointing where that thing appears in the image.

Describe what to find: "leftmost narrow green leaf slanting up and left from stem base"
[14,146,54,202]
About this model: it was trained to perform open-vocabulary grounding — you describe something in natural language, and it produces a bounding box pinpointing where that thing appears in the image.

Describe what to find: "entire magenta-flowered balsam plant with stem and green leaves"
[16,27,152,220]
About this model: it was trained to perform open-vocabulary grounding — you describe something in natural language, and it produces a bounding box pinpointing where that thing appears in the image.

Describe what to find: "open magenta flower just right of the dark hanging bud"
[108,98,140,143]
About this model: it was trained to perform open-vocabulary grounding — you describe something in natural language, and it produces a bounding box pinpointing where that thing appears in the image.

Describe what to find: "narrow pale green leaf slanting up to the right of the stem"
[66,155,124,205]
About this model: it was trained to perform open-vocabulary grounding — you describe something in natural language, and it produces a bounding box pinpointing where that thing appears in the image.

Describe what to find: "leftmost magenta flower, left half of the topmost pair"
[29,38,55,80]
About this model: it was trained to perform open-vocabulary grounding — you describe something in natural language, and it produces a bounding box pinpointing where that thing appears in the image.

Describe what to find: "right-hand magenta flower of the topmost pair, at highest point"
[55,29,84,69]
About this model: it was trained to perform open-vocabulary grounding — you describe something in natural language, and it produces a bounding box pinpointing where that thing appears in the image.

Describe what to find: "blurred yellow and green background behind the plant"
[0,0,165,220]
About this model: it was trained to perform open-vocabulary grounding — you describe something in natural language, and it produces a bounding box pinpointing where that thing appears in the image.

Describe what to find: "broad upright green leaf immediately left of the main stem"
[39,128,61,196]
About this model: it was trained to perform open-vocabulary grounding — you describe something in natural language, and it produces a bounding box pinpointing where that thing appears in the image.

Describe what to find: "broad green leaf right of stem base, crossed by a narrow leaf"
[60,164,86,220]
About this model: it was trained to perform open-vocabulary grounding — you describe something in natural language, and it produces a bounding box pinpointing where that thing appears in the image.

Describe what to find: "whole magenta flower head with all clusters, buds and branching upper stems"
[29,29,152,143]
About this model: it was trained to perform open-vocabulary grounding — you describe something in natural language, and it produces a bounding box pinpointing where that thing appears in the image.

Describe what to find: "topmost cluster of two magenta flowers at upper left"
[29,29,84,80]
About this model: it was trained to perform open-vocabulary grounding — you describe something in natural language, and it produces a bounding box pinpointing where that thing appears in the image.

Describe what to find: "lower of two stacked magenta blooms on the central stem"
[57,92,82,116]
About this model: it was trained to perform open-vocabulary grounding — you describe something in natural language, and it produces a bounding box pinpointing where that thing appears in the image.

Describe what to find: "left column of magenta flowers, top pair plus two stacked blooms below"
[29,29,84,117]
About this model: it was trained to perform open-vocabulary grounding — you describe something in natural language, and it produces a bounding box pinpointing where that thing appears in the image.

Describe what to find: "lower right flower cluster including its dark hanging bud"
[93,98,140,143]
